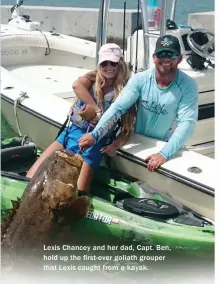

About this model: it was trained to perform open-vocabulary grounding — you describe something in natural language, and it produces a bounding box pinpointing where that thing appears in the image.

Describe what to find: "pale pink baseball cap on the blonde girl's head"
[98,43,123,64]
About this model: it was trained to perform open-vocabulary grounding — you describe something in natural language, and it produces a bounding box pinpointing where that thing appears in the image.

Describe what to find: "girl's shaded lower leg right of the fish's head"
[77,162,94,192]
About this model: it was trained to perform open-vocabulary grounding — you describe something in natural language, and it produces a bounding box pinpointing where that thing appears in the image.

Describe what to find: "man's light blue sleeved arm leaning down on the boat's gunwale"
[160,81,198,159]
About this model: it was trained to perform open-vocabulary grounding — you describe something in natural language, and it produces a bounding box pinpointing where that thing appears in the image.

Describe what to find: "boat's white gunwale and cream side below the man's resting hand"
[110,134,216,220]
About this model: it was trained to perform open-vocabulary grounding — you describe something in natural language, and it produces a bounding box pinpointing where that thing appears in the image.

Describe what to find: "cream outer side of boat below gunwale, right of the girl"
[111,154,215,220]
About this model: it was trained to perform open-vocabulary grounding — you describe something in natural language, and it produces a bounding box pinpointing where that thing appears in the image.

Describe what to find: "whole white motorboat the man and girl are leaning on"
[1,22,216,220]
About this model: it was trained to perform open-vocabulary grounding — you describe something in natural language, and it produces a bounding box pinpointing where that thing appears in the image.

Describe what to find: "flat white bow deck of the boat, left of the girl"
[7,65,90,102]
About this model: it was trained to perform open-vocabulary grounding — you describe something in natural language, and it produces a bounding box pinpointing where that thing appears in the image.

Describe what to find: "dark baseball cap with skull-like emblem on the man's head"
[154,35,181,55]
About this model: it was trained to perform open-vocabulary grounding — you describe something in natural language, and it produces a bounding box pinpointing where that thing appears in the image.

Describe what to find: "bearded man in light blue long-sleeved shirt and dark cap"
[79,35,198,171]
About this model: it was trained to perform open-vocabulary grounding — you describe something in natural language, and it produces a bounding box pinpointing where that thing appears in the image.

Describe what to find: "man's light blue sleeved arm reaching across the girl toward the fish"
[91,74,142,143]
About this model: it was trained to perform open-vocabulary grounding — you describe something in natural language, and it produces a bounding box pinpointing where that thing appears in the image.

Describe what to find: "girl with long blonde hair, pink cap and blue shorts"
[27,43,135,191]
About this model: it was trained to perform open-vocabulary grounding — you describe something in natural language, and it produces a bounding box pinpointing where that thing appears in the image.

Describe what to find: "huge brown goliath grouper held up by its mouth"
[2,151,89,251]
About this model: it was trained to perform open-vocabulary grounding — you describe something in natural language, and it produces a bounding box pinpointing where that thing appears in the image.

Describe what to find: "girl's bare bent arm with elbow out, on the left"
[72,76,100,112]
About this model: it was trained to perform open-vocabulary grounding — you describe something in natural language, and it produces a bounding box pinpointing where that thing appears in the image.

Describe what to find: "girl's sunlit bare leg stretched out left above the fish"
[26,141,64,178]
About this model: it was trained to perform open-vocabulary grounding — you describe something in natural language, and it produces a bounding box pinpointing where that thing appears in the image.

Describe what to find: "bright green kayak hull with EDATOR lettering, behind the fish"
[1,168,214,256]
